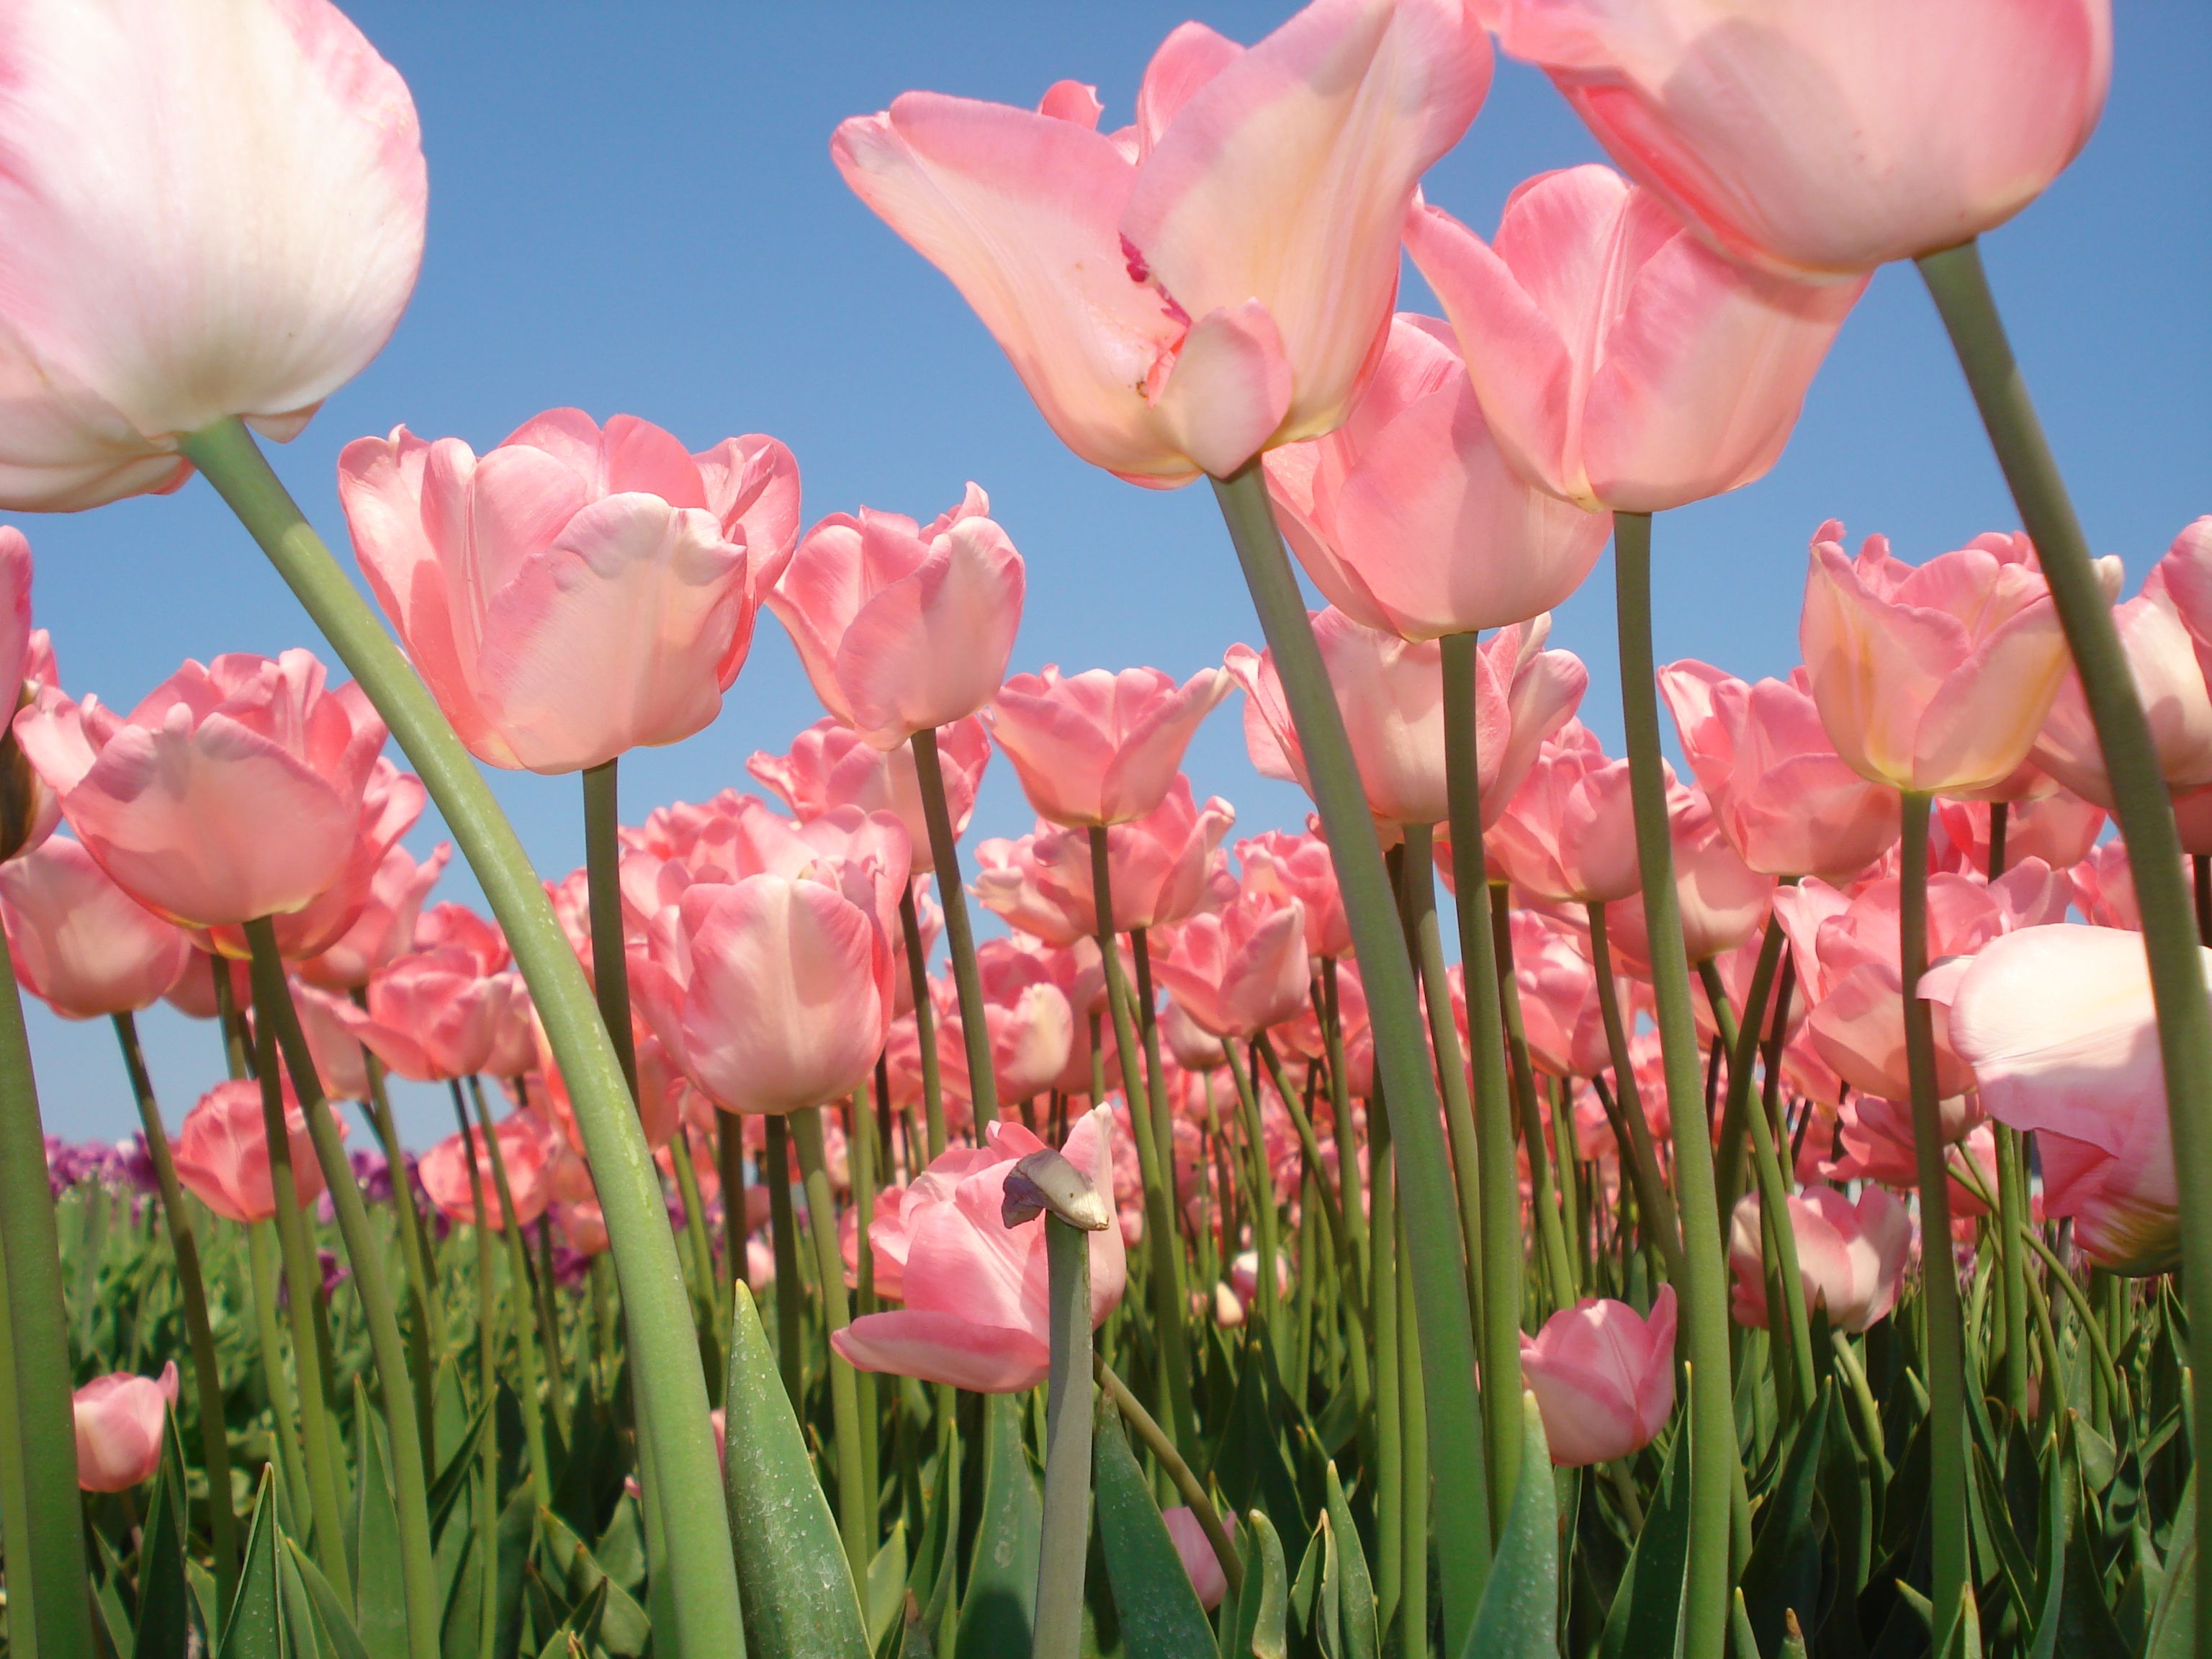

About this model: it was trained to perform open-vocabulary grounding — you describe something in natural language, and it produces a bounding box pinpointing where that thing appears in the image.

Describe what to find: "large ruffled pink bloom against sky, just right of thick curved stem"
[338,409,799,772]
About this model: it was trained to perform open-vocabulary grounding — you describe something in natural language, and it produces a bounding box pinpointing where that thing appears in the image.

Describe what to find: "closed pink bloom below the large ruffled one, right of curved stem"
[624,807,907,1115]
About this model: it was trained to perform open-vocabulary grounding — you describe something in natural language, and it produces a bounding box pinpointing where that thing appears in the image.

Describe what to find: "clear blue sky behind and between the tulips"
[20,0,2212,1143]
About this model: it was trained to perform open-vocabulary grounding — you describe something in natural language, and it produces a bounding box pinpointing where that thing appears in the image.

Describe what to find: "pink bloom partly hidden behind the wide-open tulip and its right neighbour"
[1267,312,1612,639]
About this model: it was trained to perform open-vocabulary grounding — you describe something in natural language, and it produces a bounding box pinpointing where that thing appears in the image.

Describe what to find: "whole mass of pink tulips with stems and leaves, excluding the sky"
[0,0,2212,1659]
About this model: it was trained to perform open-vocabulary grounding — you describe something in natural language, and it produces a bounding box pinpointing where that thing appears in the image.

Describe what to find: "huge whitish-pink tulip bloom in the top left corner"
[0,0,425,511]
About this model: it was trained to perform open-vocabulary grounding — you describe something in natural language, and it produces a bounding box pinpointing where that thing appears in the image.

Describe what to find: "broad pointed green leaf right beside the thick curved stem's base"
[724,1285,869,1659]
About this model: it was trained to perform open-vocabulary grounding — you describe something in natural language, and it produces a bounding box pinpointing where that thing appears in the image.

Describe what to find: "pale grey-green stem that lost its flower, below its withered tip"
[1028,1210,1090,1659]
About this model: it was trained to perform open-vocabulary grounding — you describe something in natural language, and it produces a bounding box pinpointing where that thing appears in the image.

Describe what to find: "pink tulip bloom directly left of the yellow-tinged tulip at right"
[1659,662,1898,881]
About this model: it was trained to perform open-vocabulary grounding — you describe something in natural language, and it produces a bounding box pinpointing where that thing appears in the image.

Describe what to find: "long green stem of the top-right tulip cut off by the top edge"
[1920,241,2212,1659]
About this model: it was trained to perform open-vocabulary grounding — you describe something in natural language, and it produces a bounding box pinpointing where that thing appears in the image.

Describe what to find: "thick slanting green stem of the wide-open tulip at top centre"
[1215,460,1486,1653]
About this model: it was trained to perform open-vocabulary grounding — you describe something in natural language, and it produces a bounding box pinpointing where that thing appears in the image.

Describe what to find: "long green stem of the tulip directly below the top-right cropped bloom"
[1612,513,1734,1659]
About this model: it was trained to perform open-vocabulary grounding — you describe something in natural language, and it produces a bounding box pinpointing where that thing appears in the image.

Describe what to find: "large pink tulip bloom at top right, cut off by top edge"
[1484,0,2113,274]
